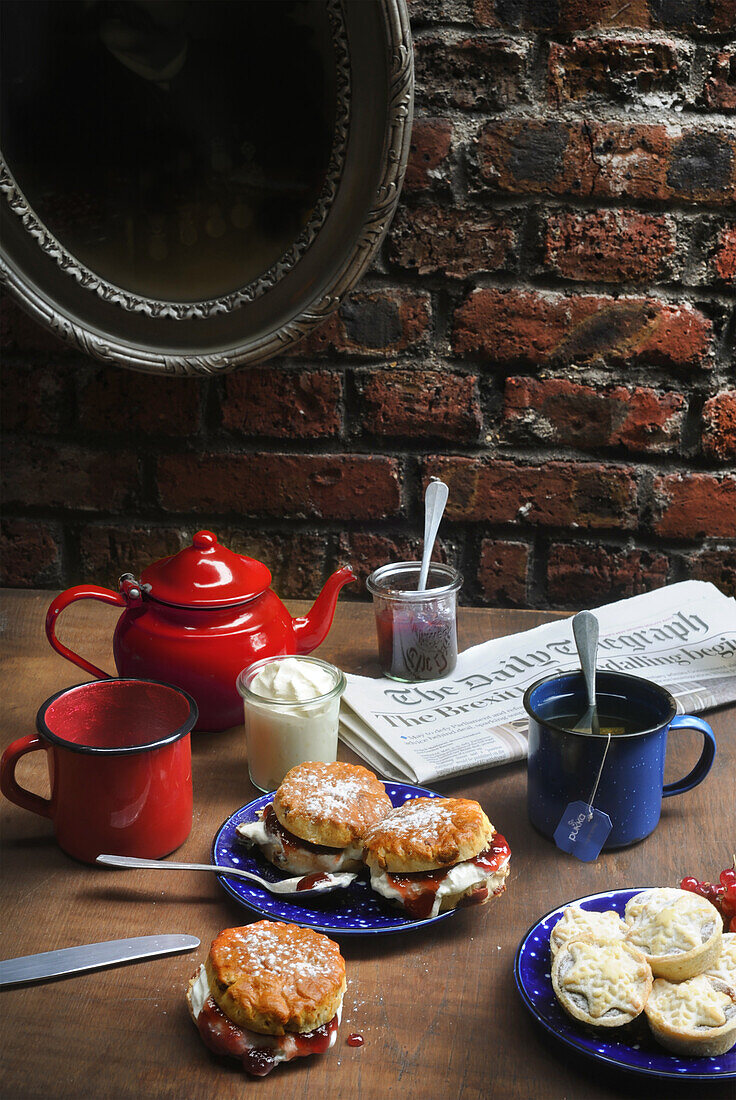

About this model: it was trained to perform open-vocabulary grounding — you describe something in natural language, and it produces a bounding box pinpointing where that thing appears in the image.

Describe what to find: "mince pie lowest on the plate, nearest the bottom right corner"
[645,974,736,1057]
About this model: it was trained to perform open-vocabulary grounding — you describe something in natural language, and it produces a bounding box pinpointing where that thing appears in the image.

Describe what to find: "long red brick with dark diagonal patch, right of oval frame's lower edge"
[453,288,712,367]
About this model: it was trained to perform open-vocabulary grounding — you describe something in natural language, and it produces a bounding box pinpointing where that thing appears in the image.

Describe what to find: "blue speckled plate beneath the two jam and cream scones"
[212,782,455,936]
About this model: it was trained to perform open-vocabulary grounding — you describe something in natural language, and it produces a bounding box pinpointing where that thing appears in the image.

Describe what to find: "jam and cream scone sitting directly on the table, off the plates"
[186,921,345,1077]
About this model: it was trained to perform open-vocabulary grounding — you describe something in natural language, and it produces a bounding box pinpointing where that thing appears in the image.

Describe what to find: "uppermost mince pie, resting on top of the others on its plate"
[625,888,723,981]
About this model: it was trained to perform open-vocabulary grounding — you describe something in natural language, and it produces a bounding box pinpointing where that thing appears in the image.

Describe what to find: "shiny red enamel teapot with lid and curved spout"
[46,531,355,730]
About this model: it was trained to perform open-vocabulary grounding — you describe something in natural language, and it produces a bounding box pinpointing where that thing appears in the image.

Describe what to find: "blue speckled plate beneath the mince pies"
[514,887,736,1081]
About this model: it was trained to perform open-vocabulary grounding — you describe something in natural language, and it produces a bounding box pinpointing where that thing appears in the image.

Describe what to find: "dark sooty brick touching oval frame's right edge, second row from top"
[414,34,529,111]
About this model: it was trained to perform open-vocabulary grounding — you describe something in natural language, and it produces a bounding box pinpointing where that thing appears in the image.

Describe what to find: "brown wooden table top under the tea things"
[0,591,736,1100]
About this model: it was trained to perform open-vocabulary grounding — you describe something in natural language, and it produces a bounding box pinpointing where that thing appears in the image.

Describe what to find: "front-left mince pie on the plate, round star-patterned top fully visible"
[552,939,652,1027]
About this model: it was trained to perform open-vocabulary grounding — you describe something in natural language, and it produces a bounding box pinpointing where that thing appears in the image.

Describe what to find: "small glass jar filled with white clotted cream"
[237,657,345,791]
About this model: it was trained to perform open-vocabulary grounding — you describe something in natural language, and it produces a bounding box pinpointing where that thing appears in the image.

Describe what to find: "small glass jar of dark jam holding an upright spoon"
[365,561,462,683]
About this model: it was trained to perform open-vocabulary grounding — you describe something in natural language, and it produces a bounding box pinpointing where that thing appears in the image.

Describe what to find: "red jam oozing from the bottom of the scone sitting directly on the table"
[197,996,338,1077]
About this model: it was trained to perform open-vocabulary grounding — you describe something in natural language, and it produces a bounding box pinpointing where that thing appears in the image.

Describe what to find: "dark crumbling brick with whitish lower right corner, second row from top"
[548,36,690,108]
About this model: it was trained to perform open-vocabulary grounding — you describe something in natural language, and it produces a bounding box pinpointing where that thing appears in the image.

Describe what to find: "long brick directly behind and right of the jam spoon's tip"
[422,455,637,529]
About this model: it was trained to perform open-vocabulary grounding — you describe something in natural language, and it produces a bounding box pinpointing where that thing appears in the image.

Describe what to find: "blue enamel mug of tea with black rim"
[524,672,715,848]
